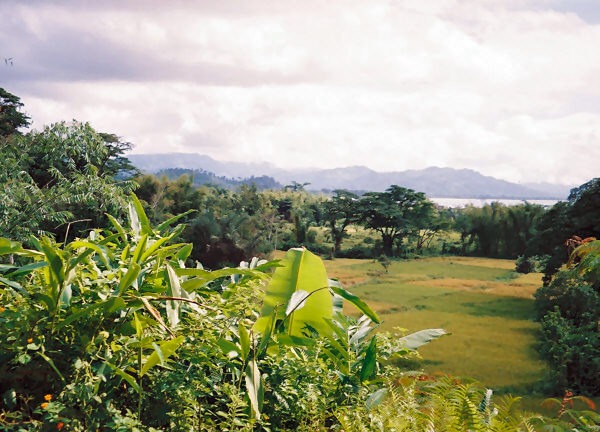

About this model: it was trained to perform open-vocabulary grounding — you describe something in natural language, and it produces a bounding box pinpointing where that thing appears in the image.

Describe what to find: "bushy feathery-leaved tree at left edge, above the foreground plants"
[0,122,135,240]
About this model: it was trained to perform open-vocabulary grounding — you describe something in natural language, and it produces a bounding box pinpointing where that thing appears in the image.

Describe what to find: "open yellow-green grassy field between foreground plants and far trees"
[318,257,545,394]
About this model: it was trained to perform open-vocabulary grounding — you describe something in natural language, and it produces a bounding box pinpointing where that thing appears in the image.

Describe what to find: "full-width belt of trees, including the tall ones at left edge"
[0,90,599,274]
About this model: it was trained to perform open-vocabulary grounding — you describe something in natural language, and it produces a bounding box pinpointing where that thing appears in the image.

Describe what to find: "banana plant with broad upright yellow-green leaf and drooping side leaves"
[248,248,447,412]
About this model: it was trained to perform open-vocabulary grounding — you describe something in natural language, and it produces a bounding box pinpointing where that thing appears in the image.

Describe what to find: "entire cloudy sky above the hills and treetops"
[0,0,600,185]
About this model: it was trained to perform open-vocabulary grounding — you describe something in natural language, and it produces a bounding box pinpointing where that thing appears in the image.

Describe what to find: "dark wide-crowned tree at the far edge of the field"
[359,185,433,256]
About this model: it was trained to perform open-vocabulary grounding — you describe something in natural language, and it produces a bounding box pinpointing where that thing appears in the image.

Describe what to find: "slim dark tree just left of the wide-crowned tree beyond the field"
[322,189,358,256]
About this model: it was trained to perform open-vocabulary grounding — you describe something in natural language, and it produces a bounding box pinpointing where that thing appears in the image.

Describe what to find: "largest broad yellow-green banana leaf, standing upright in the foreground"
[254,248,333,336]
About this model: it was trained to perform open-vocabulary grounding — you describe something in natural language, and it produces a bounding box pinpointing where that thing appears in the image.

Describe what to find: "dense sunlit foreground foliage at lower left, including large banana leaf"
[0,199,444,430]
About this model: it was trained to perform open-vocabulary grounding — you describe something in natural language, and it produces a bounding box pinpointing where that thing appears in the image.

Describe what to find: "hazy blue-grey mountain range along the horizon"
[128,153,570,200]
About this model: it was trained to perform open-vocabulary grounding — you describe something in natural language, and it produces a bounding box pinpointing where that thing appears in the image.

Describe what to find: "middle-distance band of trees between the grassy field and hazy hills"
[131,175,544,266]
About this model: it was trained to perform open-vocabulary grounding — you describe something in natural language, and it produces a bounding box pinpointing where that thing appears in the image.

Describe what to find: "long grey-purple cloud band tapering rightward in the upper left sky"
[0,5,318,87]
